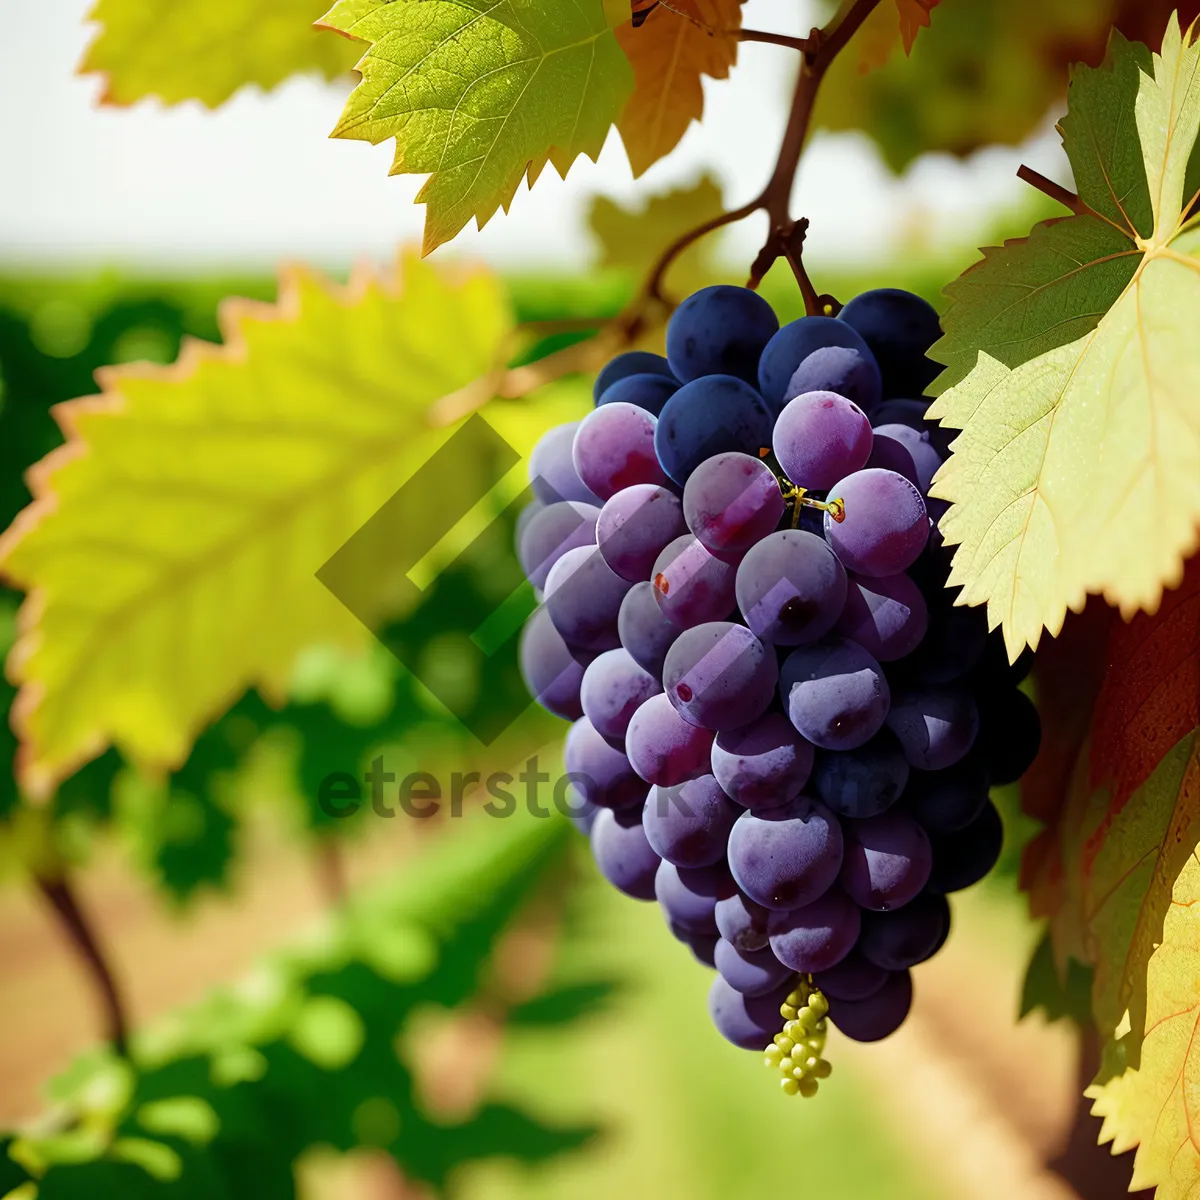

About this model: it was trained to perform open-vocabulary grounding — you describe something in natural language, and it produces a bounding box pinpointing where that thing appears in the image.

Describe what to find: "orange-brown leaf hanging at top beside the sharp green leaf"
[617,0,742,178]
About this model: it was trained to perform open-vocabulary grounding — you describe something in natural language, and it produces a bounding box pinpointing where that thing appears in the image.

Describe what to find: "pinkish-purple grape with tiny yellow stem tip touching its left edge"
[824,468,929,578]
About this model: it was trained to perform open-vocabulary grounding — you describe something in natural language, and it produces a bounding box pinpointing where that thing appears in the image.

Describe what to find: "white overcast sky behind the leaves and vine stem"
[0,0,1062,272]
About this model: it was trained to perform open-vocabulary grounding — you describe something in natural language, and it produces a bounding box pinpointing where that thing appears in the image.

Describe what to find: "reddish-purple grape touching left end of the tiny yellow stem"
[683,454,787,554]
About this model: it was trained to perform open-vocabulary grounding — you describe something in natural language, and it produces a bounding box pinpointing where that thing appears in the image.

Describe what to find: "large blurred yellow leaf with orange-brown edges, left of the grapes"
[0,260,544,791]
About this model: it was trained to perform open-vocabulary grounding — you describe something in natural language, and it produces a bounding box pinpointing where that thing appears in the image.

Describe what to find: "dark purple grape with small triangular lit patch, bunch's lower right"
[839,809,932,912]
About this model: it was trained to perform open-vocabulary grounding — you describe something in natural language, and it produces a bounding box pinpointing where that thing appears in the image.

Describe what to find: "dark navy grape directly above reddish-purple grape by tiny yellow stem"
[654,374,772,487]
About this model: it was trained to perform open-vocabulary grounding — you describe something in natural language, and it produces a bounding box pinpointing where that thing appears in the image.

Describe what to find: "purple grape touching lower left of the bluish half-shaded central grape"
[712,713,812,810]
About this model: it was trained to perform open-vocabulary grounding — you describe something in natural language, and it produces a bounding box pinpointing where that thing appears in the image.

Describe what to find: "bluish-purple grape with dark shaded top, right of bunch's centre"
[779,637,890,750]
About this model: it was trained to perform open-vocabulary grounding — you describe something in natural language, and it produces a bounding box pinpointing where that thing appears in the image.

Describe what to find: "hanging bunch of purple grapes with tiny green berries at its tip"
[518,286,1040,1096]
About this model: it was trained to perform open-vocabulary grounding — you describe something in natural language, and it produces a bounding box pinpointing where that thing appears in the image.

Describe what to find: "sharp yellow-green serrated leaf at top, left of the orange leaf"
[322,0,632,253]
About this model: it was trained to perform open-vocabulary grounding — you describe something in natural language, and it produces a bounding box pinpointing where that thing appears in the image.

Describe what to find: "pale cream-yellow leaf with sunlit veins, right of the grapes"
[930,22,1200,658]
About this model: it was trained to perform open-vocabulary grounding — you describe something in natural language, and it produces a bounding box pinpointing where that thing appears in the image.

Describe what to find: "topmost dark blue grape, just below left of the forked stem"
[667,283,779,384]
